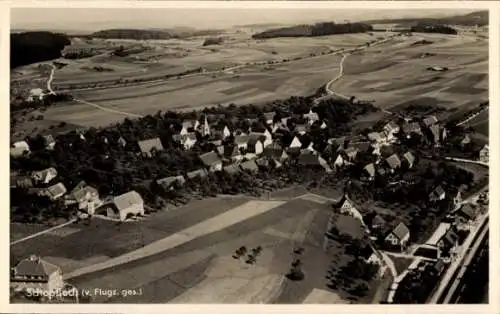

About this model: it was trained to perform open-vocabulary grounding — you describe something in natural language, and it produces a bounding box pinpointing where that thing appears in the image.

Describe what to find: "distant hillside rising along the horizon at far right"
[364,11,489,26]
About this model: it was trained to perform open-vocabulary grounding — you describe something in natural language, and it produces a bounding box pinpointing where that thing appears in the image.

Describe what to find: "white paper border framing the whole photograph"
[0,0,500,314]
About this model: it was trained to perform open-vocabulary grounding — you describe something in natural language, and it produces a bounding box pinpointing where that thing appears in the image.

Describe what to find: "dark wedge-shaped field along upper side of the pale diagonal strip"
[11,198,254,273]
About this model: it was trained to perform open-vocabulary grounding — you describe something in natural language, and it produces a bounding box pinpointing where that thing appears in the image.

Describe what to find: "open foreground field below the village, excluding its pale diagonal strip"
[11,194,372,303]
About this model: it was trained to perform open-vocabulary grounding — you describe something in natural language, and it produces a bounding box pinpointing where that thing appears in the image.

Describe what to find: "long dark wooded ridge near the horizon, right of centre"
[252,22,373,39]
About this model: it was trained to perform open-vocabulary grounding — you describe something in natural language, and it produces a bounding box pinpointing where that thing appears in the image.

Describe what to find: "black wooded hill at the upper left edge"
[10,32,71,68]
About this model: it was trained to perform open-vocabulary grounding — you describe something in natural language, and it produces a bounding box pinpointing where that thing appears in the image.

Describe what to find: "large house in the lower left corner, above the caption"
[10,255,64,295]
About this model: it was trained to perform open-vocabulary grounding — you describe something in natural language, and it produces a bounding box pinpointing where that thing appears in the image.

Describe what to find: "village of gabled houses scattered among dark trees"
[11,92,489,298]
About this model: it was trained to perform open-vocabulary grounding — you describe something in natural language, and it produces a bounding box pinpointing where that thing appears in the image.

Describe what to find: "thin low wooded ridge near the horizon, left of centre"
[85,28,221,40]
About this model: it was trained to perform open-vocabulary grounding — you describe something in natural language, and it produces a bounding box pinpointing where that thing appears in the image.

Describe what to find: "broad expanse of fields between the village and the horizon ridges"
[12,32,488,134]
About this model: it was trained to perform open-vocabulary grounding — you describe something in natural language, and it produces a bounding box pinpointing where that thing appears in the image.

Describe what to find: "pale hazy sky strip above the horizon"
[11,8,474,31]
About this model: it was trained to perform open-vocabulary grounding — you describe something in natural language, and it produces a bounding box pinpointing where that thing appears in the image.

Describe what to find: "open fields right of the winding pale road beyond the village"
[332,34,488,108]
